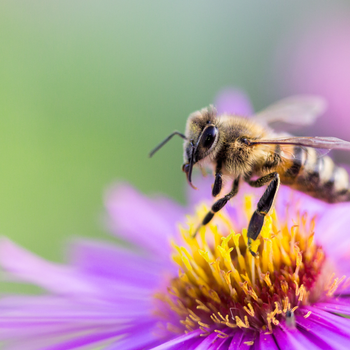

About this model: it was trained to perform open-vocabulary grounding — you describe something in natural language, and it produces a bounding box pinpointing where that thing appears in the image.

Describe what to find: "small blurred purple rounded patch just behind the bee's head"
[215,88,253,116]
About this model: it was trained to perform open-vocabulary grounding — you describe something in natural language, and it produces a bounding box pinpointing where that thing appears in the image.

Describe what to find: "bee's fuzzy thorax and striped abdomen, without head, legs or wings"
[206,115,350,203]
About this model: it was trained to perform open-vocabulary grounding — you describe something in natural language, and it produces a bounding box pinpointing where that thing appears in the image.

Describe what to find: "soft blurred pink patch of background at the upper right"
[272,11,350,163]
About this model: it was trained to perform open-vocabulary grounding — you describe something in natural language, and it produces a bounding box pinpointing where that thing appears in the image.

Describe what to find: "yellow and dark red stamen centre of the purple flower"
[156,197,345,337]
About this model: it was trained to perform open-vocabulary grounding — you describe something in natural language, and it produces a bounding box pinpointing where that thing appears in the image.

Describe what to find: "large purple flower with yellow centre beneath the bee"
[0,91,350,350]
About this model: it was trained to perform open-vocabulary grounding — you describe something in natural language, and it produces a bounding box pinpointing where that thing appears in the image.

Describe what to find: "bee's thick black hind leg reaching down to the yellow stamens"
[248,173,280,256]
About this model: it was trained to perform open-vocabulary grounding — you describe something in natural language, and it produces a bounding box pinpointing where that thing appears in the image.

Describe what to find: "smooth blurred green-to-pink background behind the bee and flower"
[0,0,350,261]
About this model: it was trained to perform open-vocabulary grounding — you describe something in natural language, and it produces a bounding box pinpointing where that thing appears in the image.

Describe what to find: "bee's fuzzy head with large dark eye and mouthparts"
[182,106,219,188]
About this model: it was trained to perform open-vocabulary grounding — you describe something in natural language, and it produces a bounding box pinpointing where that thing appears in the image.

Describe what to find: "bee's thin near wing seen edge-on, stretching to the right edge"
[249,136,350,151]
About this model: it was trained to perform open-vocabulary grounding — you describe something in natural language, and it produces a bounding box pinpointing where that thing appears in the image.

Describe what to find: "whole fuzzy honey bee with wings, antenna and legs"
[150,96,350,256]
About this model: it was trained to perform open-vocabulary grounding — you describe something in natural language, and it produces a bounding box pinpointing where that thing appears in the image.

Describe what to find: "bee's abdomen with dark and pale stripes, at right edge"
[276,147,350,203]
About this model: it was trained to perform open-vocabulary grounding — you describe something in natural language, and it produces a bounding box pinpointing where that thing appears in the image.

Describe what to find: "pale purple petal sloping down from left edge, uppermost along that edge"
[0,239,157,313]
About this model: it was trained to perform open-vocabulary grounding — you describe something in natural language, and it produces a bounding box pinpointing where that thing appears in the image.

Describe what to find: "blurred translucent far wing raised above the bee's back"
[252,95,327,126]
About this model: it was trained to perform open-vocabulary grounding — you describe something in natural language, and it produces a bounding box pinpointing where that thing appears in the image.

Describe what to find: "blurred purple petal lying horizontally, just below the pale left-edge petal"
[0,296,153,337]
